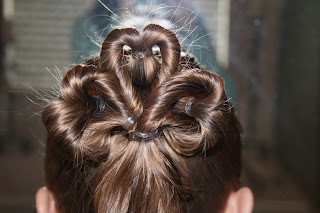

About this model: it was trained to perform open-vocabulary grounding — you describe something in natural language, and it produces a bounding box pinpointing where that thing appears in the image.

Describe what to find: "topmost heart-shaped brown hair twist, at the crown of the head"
[100,24,180,116]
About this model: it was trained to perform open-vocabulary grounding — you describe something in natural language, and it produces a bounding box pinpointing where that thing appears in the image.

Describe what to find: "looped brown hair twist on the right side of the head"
[137,70,230,154]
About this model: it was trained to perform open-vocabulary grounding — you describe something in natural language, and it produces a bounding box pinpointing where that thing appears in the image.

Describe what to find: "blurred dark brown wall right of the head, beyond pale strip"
[229,0,320,212]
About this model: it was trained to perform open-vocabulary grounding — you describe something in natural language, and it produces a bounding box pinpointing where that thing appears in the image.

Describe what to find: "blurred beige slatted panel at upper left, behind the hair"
[4,0,93,89]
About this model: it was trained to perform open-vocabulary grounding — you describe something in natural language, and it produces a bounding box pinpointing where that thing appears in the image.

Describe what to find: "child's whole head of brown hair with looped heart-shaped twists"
[42,24,241,213]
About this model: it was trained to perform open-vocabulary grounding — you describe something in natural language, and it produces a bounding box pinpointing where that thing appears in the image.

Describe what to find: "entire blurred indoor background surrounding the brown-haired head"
[0,0,320,213]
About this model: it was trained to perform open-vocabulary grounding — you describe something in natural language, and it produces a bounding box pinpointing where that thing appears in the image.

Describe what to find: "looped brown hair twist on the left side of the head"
[42,65,136,161]
